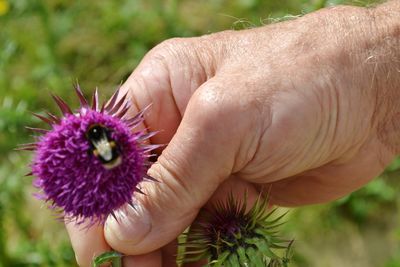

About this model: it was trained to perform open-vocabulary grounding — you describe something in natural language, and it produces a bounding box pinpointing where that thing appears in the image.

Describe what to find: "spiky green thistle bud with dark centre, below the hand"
[178,194,292,267]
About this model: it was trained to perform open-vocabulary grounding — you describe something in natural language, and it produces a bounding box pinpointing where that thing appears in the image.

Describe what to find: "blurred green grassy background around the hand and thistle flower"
[0,0,400,267]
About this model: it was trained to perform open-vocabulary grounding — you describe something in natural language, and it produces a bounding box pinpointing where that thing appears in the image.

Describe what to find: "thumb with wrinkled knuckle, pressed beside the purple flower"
[105,78,247,255]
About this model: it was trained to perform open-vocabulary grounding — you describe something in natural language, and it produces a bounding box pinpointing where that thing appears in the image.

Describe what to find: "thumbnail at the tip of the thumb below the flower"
[105,205,151,249]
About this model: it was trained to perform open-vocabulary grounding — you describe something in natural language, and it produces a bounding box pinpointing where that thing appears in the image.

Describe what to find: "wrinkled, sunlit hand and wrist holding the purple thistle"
[67,1,400,267]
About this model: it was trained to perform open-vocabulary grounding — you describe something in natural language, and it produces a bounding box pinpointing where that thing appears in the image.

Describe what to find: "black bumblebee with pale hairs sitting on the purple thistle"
[86,124,122,169]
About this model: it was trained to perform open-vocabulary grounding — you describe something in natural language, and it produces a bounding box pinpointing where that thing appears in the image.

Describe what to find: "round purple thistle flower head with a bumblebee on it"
[18,85,158,224]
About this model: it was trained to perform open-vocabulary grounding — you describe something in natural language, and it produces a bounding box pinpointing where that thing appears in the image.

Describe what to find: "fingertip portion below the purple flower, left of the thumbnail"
[65,221,110,267]
